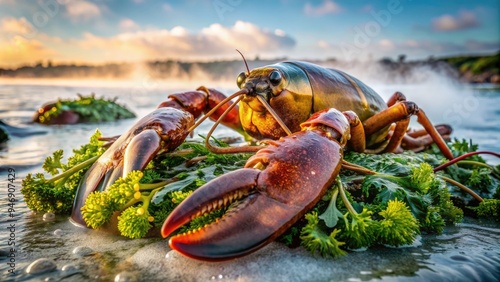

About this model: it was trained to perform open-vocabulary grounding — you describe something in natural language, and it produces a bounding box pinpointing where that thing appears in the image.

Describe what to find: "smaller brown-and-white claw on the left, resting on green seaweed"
[71,108,194,226]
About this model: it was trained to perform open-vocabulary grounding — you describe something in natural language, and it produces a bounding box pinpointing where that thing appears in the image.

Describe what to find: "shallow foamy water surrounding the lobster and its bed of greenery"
[0,82,500,281]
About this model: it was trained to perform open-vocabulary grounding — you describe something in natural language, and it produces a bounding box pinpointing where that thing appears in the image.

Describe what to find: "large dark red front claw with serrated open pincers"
[161,109,349,261]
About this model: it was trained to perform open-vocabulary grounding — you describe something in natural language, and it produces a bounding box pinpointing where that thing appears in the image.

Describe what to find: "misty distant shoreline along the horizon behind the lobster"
[0,51,500,84]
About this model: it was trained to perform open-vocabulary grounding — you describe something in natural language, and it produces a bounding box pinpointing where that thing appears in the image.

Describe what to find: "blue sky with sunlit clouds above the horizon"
[0,0,500,68]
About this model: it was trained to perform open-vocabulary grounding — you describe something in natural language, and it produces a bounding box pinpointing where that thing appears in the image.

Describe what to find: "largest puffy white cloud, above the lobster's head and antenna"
[64,21,296,62]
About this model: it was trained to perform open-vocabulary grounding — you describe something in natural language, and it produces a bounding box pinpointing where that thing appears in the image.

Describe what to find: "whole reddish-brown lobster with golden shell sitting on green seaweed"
[72,62,453,260]
